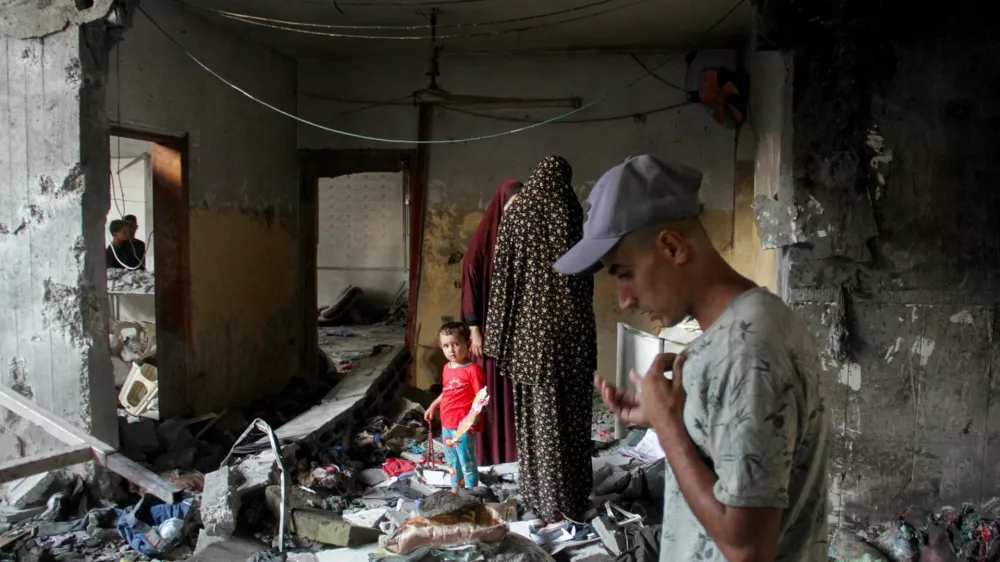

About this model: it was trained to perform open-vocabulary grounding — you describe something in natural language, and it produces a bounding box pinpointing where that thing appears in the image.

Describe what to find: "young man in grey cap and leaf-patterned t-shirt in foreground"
[555,156,830,562]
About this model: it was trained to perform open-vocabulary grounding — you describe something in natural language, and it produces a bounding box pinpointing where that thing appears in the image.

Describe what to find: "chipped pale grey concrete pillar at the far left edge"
[0,20,117,455]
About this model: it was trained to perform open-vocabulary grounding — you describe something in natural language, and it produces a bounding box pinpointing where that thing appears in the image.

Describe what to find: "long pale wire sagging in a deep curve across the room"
[137,0,748,144]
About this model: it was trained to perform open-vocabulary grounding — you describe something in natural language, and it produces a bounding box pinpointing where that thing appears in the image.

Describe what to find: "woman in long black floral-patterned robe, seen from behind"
[483,156,597,523]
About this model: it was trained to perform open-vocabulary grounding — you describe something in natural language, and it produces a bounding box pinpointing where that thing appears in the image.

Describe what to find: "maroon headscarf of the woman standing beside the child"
[462,180,521,326]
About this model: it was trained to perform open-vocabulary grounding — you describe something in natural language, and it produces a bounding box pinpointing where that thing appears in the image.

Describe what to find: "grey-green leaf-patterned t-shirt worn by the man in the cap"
[660,289,830,562]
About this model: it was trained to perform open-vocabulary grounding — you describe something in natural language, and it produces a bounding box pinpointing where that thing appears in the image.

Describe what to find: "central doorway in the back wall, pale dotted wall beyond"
[299,150,426,378]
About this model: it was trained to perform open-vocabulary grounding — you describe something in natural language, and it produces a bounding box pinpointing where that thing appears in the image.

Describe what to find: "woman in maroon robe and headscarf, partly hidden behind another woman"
[462,180,521,465]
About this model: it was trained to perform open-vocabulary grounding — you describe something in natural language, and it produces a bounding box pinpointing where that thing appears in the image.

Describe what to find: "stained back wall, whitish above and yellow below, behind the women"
[299,52,752,385]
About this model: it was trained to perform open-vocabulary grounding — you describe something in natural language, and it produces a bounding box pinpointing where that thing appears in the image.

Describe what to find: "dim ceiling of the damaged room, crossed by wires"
[174,0,752,59]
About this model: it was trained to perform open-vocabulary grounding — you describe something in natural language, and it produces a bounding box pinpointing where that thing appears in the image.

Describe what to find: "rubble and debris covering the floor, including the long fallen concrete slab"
[0,324,663,562]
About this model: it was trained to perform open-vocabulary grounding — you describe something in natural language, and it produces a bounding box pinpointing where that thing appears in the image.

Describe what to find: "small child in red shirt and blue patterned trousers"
[424,322,486,494]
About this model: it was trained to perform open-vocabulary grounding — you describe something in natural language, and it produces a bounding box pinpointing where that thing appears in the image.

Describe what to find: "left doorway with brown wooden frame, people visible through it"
[105,128,191,419]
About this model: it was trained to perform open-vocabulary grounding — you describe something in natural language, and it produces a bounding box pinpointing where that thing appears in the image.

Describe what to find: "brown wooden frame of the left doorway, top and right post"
[110,125,193,419]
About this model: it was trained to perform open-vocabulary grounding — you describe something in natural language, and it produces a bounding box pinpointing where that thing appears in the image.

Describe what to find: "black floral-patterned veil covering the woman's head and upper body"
[485,156,597,384]
